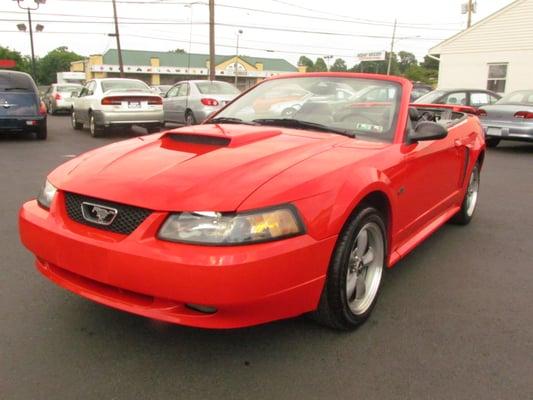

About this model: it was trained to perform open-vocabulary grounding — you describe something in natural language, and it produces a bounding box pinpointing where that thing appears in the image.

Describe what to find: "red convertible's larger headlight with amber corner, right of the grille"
[158,205,304,245]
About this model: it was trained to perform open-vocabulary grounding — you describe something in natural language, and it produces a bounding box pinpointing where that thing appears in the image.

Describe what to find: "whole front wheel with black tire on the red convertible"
[312,206,388,330]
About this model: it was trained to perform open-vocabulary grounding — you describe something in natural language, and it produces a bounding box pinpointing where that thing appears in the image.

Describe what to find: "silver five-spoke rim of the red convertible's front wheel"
[346,222,385,315]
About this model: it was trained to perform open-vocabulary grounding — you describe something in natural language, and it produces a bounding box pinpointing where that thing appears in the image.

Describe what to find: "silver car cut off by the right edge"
[478,90,533,147]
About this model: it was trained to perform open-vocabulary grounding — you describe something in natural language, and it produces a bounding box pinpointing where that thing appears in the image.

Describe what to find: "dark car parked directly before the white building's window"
[414,89,502,108]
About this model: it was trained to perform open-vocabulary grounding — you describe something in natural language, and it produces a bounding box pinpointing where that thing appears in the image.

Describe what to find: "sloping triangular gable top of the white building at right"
[428,0,533,54]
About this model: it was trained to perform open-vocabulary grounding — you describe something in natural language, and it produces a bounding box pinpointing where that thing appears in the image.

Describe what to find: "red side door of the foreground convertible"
[398,119,465,243]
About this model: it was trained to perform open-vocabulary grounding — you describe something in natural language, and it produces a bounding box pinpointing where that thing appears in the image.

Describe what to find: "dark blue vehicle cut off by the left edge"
[0,70,47,140]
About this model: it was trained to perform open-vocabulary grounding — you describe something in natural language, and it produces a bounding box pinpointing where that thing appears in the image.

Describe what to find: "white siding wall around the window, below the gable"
[438,49,533,93]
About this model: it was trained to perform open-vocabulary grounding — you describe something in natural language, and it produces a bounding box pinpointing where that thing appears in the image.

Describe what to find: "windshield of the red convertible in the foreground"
[212,76,401,142]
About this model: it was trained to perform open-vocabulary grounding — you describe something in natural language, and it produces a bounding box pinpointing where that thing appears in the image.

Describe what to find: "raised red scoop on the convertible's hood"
[161,124,281,147]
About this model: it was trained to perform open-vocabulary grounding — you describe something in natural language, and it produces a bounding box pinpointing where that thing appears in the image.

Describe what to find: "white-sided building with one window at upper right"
[429,0,533,94]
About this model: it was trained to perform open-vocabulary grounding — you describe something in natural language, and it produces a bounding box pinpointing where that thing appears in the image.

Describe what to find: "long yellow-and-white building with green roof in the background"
[70,49,304,89]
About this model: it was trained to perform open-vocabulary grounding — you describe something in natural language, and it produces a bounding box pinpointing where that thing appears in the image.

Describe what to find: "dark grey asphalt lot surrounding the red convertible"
[0,116,533,400]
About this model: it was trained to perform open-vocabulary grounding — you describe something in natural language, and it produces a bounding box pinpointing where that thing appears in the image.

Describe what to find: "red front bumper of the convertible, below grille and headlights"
[19,192,336,329]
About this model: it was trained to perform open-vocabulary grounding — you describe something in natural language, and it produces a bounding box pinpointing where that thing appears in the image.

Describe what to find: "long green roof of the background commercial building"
[103,49,298,72]
